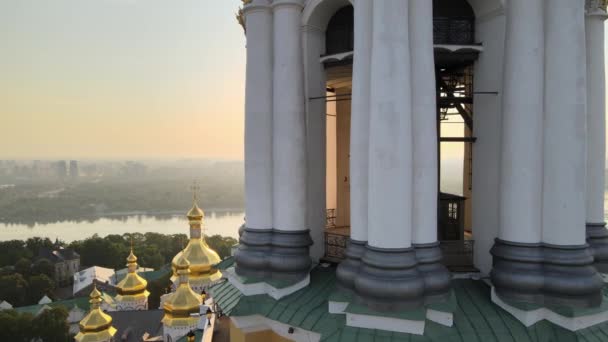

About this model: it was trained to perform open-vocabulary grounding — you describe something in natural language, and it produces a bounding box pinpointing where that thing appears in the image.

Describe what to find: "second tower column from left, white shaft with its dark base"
[268,0,312,282]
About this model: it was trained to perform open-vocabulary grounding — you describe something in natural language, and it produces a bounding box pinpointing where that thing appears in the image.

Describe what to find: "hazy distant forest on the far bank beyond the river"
[0,162,244,225]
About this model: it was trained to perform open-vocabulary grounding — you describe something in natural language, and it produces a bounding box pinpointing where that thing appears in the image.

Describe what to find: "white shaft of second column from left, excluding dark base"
[272,0,307,231]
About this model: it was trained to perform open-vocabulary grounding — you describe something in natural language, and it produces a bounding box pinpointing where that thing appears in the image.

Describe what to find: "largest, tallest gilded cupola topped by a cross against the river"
[171,186,222,292]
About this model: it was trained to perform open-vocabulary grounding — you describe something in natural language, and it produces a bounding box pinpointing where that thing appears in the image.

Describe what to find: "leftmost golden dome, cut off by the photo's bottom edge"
[74,286,116,342]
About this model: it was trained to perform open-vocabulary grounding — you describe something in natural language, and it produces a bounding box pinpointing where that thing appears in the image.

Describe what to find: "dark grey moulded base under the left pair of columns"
[235,228,312,284]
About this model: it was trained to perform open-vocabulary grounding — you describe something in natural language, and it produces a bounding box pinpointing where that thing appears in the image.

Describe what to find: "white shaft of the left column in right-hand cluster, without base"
[498,0,544,243]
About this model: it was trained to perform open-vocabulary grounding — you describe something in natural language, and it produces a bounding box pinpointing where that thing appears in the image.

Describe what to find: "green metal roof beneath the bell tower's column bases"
[211,260,608,342]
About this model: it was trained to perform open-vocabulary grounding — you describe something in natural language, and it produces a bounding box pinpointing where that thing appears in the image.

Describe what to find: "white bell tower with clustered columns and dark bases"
[223,0,608,339]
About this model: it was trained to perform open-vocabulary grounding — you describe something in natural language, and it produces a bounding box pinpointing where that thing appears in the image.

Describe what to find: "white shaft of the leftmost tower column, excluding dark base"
[244,0,272,229]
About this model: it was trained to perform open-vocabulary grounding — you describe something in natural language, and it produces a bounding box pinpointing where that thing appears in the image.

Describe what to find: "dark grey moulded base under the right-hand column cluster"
[490,239,604,308]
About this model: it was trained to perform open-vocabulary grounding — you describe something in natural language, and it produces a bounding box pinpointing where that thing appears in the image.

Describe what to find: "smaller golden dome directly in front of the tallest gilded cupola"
[162,254,203,326]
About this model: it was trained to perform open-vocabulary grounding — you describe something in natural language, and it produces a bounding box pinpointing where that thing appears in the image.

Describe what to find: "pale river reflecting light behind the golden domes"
[0,211,245,243]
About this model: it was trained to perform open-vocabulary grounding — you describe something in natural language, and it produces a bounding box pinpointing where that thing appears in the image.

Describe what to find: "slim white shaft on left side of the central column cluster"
[350,0,373,241]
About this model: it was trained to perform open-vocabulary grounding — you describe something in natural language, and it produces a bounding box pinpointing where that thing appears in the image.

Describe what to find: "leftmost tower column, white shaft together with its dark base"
[235,0,273,278]
